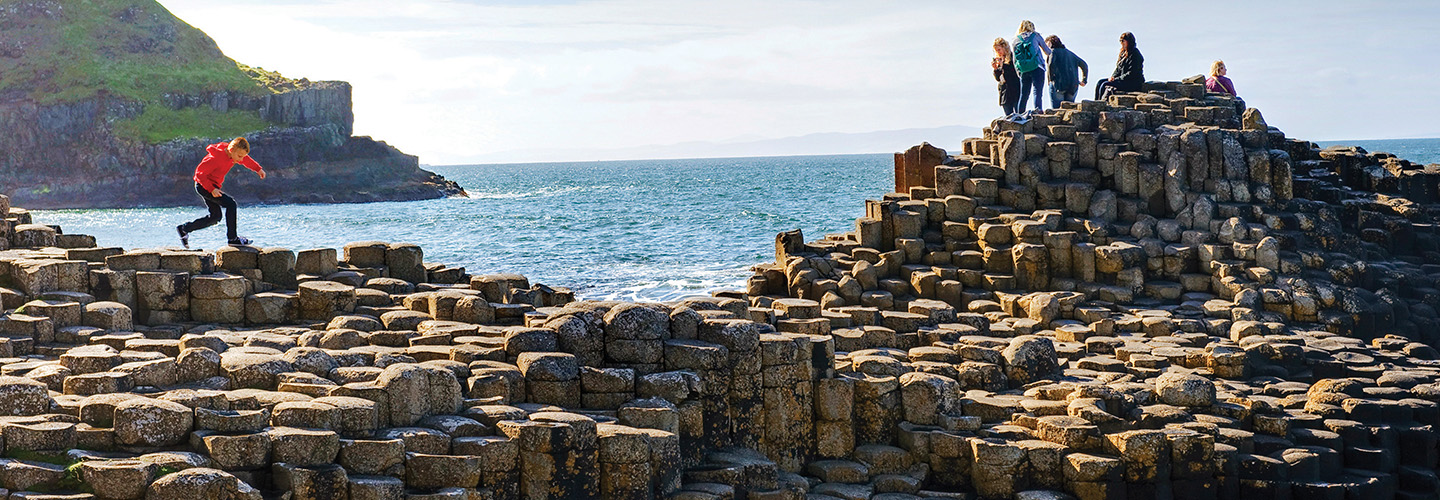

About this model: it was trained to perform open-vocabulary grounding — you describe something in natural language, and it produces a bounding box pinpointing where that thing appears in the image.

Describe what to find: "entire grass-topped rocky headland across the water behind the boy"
[0,0,464,209]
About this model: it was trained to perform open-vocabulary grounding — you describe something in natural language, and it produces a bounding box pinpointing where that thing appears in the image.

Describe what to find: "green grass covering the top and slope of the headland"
[0,0,304,144]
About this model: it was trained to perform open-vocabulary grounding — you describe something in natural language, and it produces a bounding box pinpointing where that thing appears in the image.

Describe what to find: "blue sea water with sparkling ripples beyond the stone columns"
[35,138,1440,301]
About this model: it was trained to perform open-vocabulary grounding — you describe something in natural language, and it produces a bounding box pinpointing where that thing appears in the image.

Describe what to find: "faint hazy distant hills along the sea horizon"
[474,125,981,163]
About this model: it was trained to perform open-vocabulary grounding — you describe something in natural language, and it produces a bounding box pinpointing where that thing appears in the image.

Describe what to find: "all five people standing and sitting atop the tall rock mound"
[991,20,1236,117]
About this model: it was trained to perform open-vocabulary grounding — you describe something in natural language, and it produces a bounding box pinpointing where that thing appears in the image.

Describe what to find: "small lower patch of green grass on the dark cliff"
[115,105,269,144]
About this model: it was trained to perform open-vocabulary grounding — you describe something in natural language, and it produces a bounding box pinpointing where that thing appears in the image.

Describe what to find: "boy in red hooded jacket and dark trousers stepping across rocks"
[176,137,265,248]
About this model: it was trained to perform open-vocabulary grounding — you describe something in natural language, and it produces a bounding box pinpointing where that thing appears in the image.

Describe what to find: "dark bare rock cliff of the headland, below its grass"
[0,82,464,209]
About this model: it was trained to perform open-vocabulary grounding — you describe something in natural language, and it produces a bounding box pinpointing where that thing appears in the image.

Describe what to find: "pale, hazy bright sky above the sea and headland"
[160,0,1440,164]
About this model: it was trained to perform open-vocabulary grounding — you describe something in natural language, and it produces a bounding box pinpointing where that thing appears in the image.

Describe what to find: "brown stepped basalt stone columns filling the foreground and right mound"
[0,82,1440,500]
